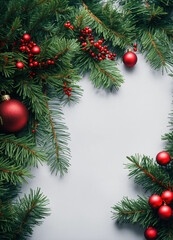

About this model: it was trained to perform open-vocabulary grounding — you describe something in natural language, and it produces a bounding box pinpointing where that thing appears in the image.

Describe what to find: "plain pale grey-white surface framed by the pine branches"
[23,55,172,240]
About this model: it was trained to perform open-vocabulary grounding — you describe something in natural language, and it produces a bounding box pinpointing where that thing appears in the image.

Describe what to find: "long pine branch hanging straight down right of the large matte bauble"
[37,90,70,175]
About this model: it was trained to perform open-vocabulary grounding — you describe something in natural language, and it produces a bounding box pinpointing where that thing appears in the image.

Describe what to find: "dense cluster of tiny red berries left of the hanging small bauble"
[80,27,116,61]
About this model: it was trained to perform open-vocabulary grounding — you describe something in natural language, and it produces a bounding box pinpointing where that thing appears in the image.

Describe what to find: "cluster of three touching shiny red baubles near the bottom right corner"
[149,190,173,220]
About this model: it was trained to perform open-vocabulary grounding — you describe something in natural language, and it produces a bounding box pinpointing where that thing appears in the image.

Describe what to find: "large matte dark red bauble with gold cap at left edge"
[0,95,29,133]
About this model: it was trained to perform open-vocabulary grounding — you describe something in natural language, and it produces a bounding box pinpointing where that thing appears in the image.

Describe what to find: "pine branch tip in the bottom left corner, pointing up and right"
[8,189,49,240]
